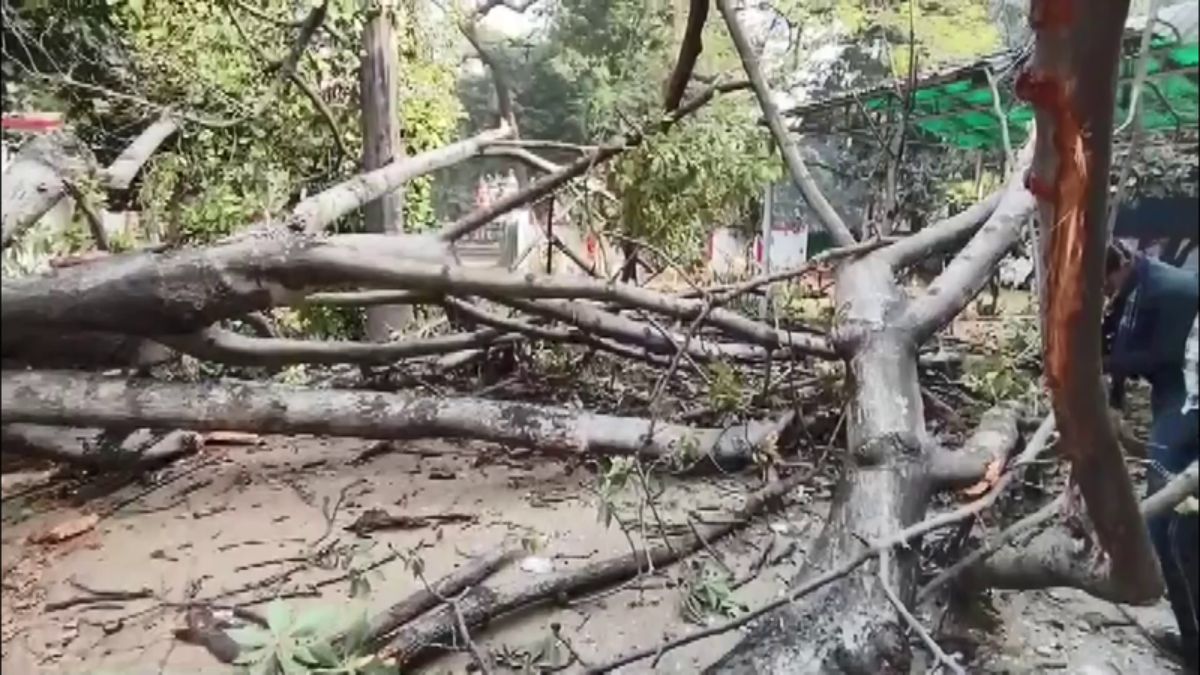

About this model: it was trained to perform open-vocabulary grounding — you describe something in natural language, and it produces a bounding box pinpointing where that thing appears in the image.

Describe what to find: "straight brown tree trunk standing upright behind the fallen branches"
[361,0,413,342]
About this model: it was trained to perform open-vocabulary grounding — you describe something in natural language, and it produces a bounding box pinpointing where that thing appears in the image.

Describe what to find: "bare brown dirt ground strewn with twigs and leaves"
[2,427,1174,674]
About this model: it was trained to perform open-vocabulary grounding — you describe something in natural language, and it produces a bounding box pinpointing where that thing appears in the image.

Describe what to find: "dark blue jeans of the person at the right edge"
[1146,408,1200,650]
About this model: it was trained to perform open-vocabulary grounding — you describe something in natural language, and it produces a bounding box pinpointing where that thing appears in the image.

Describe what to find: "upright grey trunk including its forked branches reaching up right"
[708,147,1034,674]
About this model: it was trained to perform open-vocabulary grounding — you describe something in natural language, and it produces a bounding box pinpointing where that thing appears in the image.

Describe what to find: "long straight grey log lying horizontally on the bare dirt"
[7,371,780,466]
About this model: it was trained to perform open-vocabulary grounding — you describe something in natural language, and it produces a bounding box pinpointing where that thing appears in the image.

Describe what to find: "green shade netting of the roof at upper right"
[862,38,1200,149]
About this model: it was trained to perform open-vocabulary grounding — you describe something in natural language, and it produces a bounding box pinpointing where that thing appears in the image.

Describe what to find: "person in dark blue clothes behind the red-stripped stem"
[1104,242,1200,671]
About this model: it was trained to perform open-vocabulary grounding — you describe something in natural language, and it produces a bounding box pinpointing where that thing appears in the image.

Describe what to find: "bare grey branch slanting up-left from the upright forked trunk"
[716,0,854,246]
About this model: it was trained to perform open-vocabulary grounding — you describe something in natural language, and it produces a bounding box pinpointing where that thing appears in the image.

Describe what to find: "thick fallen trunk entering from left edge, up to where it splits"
[0,231,445,340]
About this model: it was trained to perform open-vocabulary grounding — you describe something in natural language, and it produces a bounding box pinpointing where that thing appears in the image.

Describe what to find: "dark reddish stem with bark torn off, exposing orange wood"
[1018,0,1163,603]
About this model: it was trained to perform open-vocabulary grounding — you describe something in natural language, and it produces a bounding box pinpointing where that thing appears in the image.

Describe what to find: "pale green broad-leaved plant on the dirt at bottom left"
[229,601,397,675]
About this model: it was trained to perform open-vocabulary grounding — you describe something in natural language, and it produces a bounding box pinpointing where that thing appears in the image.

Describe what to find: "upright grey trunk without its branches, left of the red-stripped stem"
[710,255,930,673]
